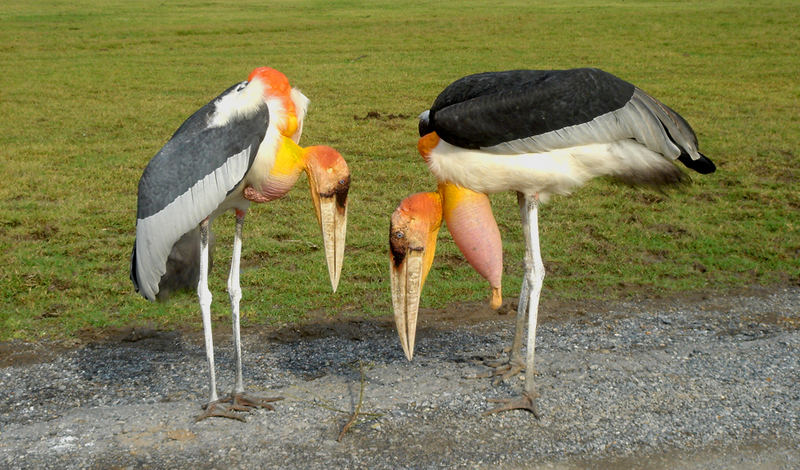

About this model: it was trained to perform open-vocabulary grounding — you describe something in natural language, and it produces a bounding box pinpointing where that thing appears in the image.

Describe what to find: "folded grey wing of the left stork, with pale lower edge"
[131,85,269,300]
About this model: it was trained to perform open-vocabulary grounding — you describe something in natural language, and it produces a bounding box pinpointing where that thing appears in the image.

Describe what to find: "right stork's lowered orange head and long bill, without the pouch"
[389,193,442,361]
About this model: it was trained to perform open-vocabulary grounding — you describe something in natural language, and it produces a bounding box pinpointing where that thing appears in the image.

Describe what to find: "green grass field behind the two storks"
[0,0,800,340]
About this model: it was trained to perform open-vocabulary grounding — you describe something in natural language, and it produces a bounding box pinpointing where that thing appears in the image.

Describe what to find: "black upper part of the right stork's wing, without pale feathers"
[429,69,634,149]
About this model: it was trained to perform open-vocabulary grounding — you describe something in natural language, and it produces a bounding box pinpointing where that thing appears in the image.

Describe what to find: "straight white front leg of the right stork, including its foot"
[484,195,544,418]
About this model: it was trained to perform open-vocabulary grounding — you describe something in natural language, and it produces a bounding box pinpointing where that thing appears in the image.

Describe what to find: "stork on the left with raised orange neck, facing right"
[131,67,350,419]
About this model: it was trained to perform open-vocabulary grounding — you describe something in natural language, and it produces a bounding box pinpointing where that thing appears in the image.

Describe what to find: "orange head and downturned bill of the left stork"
[303,145,350,292]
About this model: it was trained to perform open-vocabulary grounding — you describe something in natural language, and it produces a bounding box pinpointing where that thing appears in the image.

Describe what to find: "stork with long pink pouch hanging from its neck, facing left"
[389,68,715,416]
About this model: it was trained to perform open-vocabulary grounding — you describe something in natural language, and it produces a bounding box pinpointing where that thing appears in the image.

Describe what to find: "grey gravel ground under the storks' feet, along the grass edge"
[0,288,800,469]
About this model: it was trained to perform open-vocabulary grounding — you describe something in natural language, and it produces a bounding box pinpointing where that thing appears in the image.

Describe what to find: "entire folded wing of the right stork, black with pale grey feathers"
[420,69,714,173]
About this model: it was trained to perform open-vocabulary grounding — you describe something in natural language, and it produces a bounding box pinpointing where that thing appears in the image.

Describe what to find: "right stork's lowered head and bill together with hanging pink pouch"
[389,183,503,360]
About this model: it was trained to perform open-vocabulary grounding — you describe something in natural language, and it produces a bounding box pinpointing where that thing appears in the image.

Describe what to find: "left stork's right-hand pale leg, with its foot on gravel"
[223,209,282,411]
